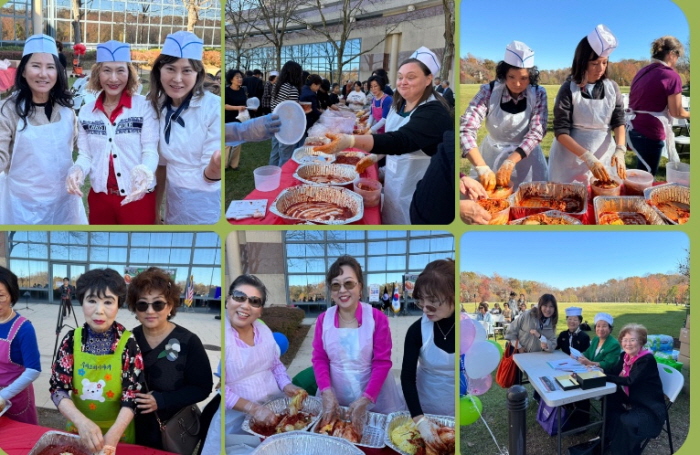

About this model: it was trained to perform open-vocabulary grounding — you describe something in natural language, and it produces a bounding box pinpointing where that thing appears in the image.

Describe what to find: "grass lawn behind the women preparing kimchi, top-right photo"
[456,84,690,181]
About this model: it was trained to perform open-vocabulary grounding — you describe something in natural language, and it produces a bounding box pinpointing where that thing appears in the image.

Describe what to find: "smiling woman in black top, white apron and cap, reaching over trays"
[314,47,453,224]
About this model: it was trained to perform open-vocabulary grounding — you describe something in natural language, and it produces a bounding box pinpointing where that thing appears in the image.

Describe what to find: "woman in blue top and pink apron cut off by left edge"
[0,266,41,425]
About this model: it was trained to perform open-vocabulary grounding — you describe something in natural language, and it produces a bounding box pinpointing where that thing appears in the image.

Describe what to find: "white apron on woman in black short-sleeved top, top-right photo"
[549,79,616,185]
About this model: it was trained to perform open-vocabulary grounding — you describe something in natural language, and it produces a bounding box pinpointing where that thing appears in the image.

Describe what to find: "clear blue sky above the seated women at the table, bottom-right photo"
[460,231,688,289]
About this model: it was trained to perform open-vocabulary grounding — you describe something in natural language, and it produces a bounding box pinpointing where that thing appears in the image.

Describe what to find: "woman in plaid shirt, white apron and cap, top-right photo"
[460,41,547,191]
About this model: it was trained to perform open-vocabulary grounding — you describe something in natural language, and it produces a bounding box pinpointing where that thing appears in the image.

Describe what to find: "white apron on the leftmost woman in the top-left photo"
[0,106,87,225]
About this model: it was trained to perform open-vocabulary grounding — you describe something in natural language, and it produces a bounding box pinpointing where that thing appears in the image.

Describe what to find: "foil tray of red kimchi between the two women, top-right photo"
[508,182,588,220]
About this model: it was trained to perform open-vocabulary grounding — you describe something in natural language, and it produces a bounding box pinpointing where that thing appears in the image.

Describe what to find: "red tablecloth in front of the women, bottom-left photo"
[0,417,173,455]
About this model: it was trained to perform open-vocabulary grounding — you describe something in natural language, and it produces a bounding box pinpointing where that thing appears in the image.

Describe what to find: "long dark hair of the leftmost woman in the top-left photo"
[3,54,73,131]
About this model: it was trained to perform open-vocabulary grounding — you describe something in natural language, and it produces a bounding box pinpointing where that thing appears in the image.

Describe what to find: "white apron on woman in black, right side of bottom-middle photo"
[416,315,455,416]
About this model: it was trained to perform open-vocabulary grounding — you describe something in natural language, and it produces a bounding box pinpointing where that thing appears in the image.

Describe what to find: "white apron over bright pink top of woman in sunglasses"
[323,302,406,414]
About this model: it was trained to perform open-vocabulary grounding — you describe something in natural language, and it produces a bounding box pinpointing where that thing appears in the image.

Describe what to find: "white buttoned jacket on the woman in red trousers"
[75,95,159,196]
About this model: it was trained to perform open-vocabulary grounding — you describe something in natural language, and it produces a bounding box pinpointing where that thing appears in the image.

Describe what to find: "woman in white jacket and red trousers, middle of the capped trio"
[66,41,158,224]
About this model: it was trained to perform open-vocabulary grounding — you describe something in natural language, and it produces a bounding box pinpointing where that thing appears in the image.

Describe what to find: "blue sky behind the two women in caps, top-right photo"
[460,0,689,69]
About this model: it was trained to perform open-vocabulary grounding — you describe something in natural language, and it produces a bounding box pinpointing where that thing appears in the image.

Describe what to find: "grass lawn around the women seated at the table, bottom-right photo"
[460,302,690,455]
